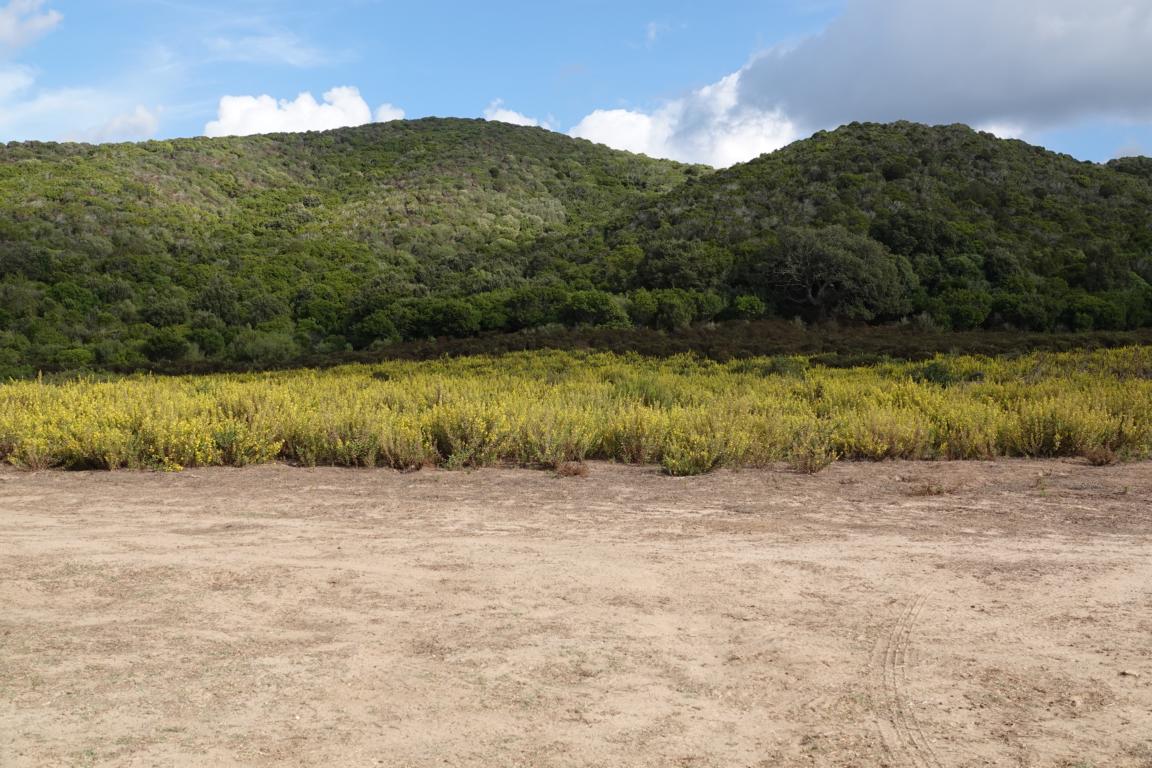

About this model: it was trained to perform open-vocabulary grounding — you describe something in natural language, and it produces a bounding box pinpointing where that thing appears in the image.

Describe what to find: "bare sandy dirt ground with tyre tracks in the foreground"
[0,462,1152,768]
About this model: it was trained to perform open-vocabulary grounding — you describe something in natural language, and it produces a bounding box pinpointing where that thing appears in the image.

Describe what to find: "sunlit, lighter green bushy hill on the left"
[0,120,706,374]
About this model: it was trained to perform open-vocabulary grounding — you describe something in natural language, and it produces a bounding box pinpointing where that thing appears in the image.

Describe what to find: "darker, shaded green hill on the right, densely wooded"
[541,123,1152,330]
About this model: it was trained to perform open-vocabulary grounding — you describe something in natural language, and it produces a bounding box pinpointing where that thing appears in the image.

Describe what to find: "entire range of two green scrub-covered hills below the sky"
[0,120,1152,375]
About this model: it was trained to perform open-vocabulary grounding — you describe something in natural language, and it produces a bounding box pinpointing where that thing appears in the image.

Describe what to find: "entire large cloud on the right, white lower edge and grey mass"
[570,0,1152,166]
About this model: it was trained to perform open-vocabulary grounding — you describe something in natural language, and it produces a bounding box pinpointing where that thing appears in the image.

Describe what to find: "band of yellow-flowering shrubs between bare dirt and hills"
[0,348,1152,474]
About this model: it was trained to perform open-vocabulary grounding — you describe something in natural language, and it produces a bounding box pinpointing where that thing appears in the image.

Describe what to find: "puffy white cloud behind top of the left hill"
[204,85,404,136]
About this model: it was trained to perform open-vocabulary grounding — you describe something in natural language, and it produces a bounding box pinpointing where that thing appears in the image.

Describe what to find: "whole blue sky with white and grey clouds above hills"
[0,0,1152,165]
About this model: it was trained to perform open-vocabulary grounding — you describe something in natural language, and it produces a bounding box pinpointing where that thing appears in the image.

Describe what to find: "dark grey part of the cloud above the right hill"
[740,0,1152,132]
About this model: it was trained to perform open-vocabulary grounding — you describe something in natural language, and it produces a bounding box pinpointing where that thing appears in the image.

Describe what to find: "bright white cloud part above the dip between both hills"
[569,73,799,167]
